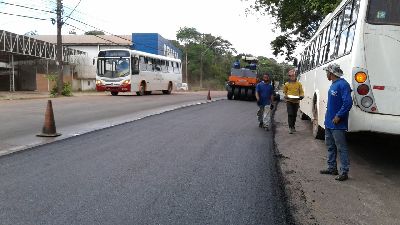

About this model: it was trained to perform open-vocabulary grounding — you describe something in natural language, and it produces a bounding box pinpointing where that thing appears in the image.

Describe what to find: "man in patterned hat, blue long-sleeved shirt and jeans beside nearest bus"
[320,64,353,181]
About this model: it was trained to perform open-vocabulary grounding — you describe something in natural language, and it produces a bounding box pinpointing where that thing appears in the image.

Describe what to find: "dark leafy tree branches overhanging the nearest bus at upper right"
[250,0,341,60]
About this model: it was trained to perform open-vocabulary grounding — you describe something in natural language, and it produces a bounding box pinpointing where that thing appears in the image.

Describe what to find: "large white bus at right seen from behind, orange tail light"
[298,0,400,138]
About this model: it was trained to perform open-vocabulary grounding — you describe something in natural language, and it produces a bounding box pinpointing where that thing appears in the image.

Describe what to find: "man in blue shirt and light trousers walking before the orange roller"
[256,74,274,130]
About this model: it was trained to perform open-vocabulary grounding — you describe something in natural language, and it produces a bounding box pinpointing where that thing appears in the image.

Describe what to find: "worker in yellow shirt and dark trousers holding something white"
[283,69,304,134]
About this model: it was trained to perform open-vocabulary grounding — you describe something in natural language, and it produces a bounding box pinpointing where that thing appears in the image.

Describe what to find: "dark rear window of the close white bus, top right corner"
[367,0,400,25]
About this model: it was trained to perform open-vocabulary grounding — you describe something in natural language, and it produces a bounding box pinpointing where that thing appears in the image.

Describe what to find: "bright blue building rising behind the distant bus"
[132,33,182,59]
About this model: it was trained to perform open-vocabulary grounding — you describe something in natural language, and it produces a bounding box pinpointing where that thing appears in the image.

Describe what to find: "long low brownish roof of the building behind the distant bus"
[31,35,132,46]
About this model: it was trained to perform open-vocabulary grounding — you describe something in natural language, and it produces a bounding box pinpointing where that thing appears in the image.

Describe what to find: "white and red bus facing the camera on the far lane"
[96,49,182,96]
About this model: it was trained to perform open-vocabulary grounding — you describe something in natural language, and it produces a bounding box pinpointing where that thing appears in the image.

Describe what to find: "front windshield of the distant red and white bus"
[97,58,129,78]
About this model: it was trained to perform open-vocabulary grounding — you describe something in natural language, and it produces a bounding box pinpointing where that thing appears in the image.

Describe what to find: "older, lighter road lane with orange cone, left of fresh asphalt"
[0,92,226,155]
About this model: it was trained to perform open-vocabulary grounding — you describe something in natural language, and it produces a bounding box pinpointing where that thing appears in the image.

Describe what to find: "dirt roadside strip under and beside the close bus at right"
[275,102,400,225]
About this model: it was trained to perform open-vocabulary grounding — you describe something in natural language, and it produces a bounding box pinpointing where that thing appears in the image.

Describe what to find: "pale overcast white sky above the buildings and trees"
[0,0,281,61]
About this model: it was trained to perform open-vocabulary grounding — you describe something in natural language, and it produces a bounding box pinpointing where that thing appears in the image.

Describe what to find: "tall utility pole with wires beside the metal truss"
[56,0,64,95]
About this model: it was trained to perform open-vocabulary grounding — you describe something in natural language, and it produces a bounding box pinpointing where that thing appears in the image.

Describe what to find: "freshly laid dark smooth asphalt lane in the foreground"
[0,100,289,225]
